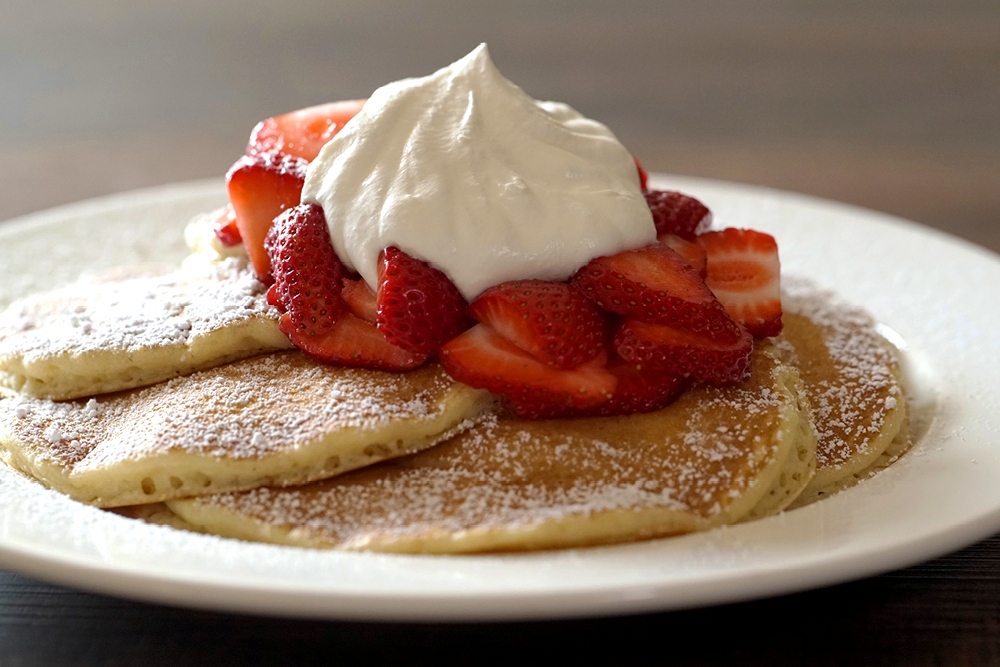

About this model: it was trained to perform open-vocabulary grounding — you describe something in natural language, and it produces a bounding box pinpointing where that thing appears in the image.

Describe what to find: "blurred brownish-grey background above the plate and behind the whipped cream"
[0,0,1000,251]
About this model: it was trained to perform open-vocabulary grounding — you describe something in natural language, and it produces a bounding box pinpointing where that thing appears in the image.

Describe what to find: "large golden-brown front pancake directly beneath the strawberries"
[167,349,814,553]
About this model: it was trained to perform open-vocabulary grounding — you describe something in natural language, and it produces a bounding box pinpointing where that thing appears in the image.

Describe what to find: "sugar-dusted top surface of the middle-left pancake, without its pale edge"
[0,352,455,470]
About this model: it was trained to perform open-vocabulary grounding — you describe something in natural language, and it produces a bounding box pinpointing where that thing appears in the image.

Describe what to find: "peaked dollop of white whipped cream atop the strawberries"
[302,44,656,301]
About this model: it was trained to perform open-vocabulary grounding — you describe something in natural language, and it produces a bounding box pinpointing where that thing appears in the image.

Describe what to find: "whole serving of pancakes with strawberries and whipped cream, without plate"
[0,46,968,620]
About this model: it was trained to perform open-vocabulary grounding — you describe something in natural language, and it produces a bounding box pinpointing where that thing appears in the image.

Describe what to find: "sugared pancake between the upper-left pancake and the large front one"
[0,351,492,507]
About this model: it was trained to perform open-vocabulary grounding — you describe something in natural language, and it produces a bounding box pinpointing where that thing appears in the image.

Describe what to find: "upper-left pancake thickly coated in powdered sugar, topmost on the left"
[0,258,291,400]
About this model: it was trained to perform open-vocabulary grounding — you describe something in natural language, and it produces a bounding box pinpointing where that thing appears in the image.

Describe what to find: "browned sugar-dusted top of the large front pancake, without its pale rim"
[197,354,793,545]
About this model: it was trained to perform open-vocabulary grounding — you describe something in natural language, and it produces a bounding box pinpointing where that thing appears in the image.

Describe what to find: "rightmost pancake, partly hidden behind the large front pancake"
[775,281,911,507]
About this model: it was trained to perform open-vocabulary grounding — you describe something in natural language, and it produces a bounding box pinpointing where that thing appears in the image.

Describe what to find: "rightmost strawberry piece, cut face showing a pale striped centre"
[698,228,782,338]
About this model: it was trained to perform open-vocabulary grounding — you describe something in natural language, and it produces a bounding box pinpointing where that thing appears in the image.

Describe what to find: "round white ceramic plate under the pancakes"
[0,176,1000,620]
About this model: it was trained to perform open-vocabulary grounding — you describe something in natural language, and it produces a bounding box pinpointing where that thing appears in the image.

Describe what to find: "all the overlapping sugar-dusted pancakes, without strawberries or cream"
[0,258,910,553]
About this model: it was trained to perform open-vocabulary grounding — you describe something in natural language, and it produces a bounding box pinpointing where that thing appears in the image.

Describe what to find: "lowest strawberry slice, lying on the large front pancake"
[440,324,617,419]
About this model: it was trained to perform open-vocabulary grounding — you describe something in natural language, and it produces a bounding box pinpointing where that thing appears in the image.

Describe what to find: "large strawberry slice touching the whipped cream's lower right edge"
[572,243,741,341]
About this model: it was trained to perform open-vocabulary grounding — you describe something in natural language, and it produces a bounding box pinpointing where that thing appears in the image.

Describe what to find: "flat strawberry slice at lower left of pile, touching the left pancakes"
[278,312,427,371]
